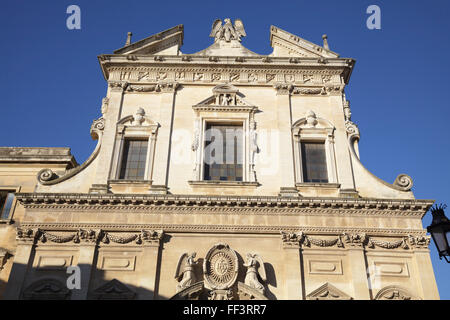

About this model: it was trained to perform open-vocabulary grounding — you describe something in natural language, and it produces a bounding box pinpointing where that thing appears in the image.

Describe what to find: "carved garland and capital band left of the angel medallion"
[16,227,164,245]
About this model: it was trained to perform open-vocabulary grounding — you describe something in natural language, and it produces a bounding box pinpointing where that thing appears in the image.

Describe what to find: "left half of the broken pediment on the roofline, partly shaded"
[114,24,184,55]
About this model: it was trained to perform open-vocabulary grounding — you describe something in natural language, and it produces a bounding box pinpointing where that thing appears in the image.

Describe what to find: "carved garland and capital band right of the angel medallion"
[281,231,430,250]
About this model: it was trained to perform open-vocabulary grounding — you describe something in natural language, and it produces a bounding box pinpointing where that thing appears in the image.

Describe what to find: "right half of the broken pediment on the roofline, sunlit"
[270,26,339,58]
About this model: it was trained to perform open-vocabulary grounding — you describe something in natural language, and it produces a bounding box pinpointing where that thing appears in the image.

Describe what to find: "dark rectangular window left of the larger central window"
[119,139,148,180]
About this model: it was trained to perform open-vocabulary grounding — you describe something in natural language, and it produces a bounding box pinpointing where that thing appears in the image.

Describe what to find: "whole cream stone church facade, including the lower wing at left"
[0,19,439,300]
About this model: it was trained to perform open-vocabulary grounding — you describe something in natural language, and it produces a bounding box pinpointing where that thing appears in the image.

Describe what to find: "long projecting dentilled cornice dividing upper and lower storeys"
[16,193,433,217]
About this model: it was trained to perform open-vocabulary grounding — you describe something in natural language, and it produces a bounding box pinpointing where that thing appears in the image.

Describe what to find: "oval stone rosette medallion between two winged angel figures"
[203,243,238,289]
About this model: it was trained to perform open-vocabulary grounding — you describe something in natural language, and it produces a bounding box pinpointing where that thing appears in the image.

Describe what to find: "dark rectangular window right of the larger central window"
[301,142,328,183]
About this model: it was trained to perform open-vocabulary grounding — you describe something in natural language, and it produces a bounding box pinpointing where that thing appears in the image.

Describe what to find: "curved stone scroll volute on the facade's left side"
[37,117,105,186]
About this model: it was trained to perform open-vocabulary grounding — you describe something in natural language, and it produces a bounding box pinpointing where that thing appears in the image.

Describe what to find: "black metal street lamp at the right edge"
[427,204,450,263]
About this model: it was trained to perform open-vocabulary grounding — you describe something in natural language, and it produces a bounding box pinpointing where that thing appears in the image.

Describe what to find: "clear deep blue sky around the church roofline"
[0,0,450,299]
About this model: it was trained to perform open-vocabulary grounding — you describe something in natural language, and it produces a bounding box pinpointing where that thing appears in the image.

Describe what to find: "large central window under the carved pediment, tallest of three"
[203,123,243,181]
